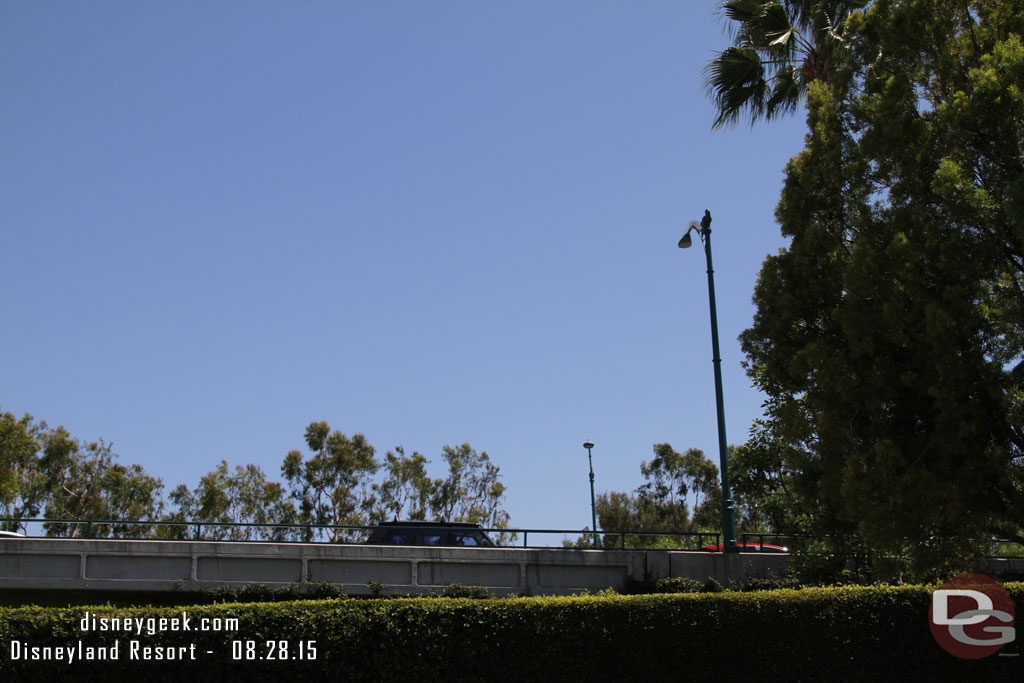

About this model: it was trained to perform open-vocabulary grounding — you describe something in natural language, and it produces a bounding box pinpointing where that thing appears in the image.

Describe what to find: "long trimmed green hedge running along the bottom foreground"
[0,584,1024,683]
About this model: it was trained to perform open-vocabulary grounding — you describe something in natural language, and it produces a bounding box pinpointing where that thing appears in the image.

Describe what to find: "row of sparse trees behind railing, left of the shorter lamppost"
[0,413,514,543]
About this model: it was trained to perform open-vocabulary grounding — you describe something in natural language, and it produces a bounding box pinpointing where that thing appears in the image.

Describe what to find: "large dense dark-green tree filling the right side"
[736,0,1024,579]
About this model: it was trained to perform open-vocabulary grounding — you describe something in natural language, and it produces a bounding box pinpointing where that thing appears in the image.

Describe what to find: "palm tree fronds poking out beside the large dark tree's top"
[705,0,869,128]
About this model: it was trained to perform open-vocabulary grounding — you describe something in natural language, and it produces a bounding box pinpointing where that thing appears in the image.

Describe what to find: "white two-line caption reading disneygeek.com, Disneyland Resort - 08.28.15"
[7,611,316,665]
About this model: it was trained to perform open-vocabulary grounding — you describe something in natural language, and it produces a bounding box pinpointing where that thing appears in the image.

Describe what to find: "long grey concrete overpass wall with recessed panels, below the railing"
[0,538,787,595]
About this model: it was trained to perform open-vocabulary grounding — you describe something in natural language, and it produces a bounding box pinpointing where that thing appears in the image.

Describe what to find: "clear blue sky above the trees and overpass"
[6,0,804,528]
